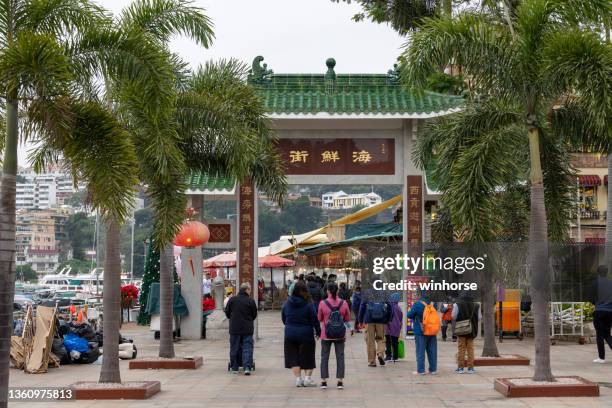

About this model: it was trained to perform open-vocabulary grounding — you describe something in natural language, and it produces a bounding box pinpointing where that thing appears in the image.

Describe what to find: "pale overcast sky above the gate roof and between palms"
[20,0,404,165]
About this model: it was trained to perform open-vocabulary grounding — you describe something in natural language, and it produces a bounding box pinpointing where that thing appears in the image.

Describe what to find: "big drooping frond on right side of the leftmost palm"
[28,98,137,222]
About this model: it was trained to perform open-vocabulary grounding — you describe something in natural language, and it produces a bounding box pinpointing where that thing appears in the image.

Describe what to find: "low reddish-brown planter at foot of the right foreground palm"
[493,376,599,398]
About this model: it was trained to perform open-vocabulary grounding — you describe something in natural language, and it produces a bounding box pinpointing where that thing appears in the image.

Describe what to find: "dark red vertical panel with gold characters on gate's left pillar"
[238,180,257,286]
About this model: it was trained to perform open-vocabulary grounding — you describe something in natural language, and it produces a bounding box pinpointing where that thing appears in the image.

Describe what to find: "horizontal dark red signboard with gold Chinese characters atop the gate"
[278,138,395,175]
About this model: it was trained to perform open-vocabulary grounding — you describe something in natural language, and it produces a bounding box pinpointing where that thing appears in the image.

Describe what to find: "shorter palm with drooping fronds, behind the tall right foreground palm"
[413,99,572,357]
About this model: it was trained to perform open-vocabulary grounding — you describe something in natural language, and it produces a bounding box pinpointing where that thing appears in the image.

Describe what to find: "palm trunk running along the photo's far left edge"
[0,98,19,408]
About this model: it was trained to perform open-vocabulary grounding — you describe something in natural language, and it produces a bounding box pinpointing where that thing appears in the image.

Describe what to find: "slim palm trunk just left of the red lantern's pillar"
[159,244,178,358]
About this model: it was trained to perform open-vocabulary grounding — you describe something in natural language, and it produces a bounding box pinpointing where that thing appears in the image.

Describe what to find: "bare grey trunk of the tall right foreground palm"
[529,127,554,381]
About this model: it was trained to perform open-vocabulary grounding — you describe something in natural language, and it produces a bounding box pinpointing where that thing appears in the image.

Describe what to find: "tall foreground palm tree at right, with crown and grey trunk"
[403,0,612,381]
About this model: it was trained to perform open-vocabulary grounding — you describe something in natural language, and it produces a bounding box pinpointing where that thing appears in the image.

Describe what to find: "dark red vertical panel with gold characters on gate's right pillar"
[404,176,423,270]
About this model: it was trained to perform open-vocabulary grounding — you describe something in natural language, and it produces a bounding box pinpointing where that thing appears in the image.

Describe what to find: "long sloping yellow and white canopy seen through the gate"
[270,194,402,255]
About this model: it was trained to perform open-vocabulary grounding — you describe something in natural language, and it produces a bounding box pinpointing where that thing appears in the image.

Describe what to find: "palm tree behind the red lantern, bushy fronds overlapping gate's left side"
[150,60,286,358]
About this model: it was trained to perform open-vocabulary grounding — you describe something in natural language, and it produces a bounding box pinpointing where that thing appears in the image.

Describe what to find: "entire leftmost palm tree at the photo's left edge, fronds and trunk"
[0,0,136,406]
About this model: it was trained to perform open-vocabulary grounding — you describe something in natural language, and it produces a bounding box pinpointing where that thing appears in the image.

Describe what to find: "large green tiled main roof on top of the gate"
[249,57,463,116]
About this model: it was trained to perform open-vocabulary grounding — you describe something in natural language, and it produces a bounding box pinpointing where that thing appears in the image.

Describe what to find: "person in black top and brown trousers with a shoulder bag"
[452,291,479,374]
